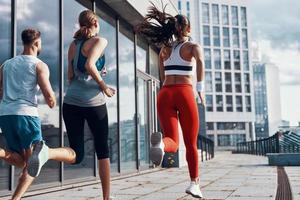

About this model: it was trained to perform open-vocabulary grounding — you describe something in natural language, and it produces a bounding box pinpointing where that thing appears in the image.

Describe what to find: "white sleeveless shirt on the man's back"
[0,55,42,116]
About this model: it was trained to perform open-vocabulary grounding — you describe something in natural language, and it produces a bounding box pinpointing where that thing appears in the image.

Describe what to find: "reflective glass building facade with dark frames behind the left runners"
[0,0,159,197]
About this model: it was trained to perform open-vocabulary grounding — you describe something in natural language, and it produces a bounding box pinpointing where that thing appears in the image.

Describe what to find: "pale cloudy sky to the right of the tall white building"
[248,0,300,125]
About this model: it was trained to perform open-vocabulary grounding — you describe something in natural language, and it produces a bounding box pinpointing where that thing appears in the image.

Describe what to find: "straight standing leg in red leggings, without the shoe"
[176,87,199,182]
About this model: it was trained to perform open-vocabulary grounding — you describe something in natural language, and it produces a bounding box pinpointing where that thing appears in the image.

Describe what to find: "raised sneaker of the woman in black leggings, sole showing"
[28,141,49,177]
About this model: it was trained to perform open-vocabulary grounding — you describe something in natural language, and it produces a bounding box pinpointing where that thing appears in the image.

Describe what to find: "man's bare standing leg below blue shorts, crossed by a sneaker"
[12,149,34,200]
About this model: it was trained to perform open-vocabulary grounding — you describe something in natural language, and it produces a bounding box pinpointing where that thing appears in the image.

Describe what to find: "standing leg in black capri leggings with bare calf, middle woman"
[85,105,110,200]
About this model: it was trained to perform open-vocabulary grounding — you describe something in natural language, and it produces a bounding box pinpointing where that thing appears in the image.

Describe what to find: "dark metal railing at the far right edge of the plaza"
[235,131,300,156]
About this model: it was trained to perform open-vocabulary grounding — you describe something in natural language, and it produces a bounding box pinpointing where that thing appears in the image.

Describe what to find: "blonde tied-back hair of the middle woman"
[74,10,98,40]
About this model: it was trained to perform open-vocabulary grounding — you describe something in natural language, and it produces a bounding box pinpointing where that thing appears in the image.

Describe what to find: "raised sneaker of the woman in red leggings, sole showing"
[150,132,165,166]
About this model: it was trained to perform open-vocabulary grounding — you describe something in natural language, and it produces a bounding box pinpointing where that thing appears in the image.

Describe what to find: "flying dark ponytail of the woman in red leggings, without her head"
[136,3,176,46]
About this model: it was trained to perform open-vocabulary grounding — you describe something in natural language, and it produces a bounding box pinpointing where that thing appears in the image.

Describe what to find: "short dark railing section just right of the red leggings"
[198,135,215,162]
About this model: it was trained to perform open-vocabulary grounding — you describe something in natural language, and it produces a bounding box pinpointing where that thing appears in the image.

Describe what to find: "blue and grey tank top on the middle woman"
[64,40,106,107]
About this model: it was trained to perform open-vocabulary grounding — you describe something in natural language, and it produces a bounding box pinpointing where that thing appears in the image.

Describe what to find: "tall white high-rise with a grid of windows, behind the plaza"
[198,0,255,148]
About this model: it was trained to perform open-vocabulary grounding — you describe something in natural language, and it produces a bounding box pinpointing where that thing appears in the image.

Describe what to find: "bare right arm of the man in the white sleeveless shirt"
[36,62,56,108]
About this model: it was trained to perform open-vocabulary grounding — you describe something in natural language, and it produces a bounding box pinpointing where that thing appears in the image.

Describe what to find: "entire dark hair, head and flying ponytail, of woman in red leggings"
[135,3,190,46]
